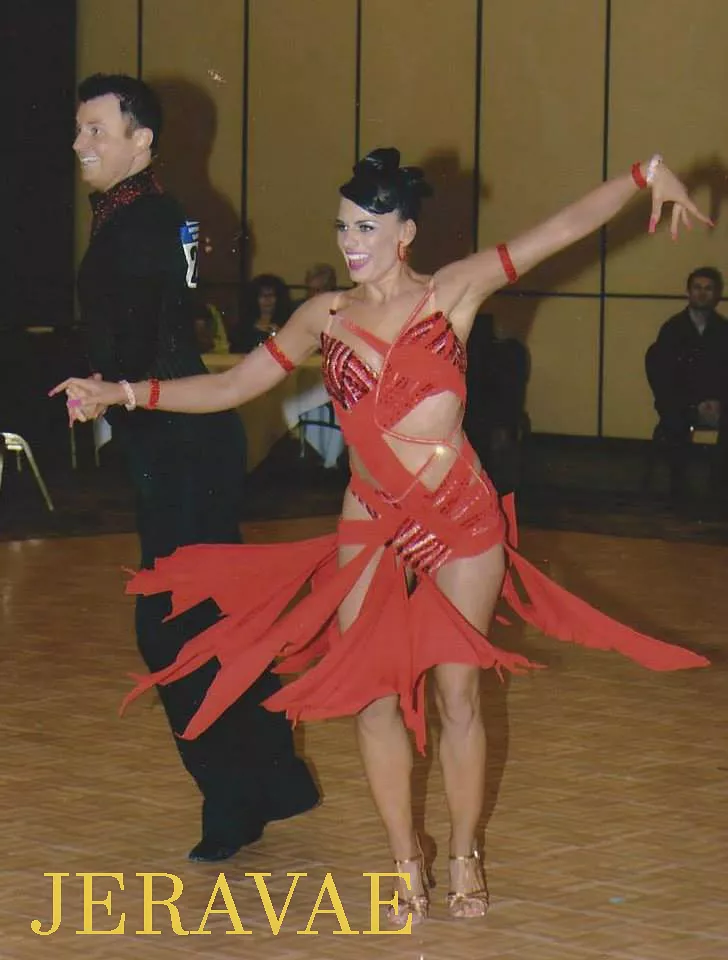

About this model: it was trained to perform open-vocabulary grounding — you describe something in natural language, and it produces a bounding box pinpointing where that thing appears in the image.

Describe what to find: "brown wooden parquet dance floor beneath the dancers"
[0,520,728,960]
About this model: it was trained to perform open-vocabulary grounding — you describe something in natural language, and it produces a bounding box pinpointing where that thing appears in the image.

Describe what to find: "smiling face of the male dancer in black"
[73,93,151,193]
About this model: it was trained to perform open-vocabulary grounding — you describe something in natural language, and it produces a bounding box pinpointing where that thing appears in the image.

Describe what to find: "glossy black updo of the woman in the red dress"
[339,147,432,223]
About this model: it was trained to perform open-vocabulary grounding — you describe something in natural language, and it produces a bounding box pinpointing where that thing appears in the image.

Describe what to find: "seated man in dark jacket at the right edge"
[645,267,728,496]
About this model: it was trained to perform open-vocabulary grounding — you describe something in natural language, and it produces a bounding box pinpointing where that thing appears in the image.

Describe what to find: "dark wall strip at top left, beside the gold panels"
[6,0,76,327]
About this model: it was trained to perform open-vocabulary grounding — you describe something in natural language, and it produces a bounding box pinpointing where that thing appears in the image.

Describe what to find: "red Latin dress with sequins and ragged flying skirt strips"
[125,274,708,750]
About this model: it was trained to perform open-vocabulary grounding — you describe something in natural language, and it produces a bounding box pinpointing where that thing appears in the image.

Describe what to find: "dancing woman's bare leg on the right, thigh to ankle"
[434,547,505,916]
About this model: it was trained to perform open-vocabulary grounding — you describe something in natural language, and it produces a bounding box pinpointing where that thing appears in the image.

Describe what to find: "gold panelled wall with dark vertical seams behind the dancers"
[72,0,728,438]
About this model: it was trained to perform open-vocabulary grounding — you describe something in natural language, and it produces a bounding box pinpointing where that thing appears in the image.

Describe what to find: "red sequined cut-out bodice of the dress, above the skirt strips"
[321,287,484,571]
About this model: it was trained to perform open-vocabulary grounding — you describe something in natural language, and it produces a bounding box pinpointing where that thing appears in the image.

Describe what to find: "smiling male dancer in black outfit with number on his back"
[73,75,318,861]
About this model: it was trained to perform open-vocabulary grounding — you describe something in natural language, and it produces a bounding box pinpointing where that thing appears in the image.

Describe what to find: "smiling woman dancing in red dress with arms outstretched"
[52,148,709,925]
